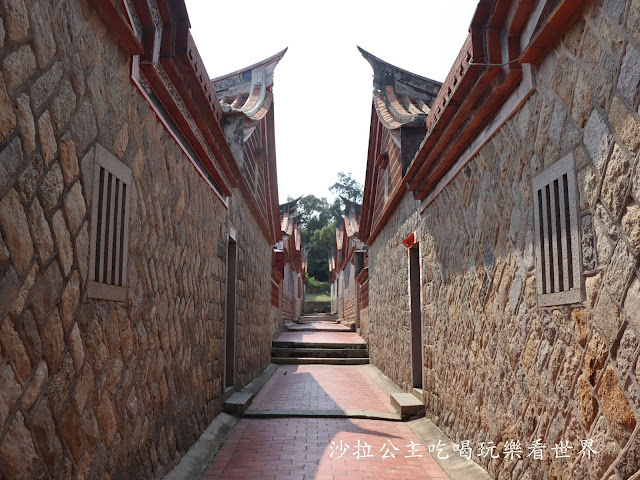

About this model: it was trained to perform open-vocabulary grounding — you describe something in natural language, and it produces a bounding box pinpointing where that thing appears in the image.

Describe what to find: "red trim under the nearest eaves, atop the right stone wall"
[407,0,589,200]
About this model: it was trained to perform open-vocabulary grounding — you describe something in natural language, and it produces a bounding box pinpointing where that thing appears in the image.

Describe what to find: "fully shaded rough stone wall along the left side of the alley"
[0,0,271,480]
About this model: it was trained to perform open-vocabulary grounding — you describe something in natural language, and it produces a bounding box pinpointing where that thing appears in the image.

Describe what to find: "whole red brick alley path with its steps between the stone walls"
[192,317,488,480]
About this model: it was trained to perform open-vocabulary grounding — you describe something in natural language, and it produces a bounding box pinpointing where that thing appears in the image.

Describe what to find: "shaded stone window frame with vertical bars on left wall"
[87,148,133,302]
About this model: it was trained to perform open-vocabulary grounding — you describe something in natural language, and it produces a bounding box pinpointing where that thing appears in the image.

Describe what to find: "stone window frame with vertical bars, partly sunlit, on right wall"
[532,152,583,307]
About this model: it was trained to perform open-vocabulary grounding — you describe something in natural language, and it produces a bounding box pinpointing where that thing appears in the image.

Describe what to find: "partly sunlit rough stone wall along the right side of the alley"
[368,0,640,480]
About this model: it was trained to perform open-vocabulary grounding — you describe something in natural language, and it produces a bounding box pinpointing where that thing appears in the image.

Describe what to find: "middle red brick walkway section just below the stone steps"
[248,365,395,413]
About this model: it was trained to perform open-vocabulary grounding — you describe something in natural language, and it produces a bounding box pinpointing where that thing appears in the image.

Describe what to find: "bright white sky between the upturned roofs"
[186,0,478,203]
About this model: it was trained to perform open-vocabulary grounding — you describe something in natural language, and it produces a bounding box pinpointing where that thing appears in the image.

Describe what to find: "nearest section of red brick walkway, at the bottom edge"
[202,418,449,480]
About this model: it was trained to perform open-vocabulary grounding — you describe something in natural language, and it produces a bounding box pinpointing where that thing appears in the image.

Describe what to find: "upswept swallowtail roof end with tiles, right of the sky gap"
[358,47,442,130]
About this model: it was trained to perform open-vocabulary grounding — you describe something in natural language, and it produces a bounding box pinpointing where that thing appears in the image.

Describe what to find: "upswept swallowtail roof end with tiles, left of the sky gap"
[211,48,287,141]
